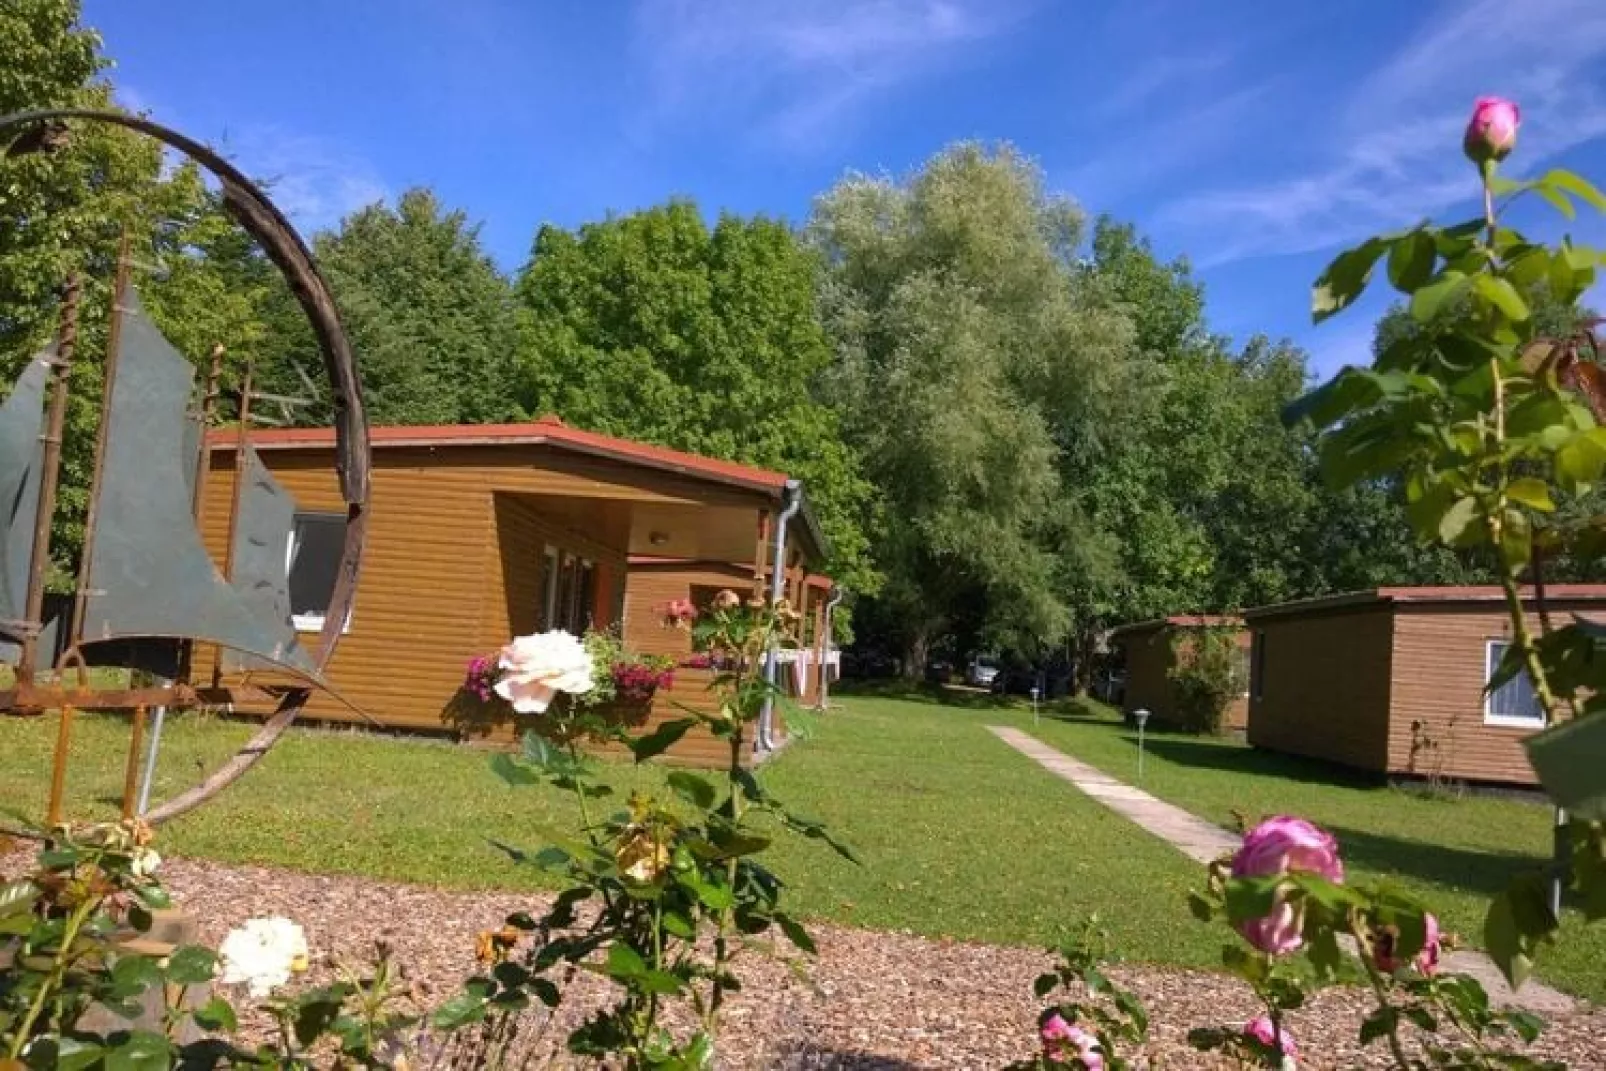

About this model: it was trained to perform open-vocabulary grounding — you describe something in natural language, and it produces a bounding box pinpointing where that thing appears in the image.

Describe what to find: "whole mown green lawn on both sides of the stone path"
[0,695,1606,1000]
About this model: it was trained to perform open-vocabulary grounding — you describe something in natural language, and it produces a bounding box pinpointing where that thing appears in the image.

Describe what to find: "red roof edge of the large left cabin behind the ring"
[207,416,787,491]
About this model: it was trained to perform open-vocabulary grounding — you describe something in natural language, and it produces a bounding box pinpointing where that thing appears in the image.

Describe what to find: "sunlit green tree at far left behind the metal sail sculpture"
[0,0,269,588]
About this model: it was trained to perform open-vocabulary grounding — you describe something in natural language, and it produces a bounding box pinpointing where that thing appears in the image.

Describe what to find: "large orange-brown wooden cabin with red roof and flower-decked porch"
[198,417,825,764]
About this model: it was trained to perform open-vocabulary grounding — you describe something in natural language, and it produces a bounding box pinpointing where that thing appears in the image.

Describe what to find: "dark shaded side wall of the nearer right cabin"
[1248,605,1394,772]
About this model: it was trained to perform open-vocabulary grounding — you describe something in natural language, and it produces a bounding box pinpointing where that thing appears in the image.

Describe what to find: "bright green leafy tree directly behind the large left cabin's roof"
[517,201,877,593]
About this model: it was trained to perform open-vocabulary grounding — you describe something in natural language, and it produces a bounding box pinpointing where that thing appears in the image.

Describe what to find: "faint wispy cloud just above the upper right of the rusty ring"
[220,125,390,231]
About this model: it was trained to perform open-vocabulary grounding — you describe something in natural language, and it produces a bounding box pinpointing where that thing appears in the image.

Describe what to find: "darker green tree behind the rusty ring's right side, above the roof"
[263,189,519,424]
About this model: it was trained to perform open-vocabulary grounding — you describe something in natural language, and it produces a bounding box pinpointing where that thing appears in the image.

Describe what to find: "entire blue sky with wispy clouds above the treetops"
[85,0,1606,371]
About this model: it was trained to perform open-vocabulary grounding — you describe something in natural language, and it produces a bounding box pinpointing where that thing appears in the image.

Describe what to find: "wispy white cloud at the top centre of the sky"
[636,0,1033,151]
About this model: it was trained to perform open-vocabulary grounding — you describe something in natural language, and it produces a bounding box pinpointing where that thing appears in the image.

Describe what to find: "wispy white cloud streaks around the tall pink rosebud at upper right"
[1156,0,1606,267]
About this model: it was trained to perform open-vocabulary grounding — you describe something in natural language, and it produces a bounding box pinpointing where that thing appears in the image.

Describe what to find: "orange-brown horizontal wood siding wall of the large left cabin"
[196,448,693,739]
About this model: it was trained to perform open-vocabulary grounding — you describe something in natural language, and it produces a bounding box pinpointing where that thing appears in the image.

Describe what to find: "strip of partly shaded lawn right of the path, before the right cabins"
[1028,703,1606,1000]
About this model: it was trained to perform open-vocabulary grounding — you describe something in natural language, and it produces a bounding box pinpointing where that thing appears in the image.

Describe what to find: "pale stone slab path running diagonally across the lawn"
[988,726,1577,1015]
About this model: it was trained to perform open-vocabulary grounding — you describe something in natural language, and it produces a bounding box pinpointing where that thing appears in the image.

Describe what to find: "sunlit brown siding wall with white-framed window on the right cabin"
[1388,602,1600,785]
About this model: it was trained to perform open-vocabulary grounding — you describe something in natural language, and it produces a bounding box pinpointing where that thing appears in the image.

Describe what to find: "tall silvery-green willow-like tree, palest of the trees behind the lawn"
[809,145,1132,673]
